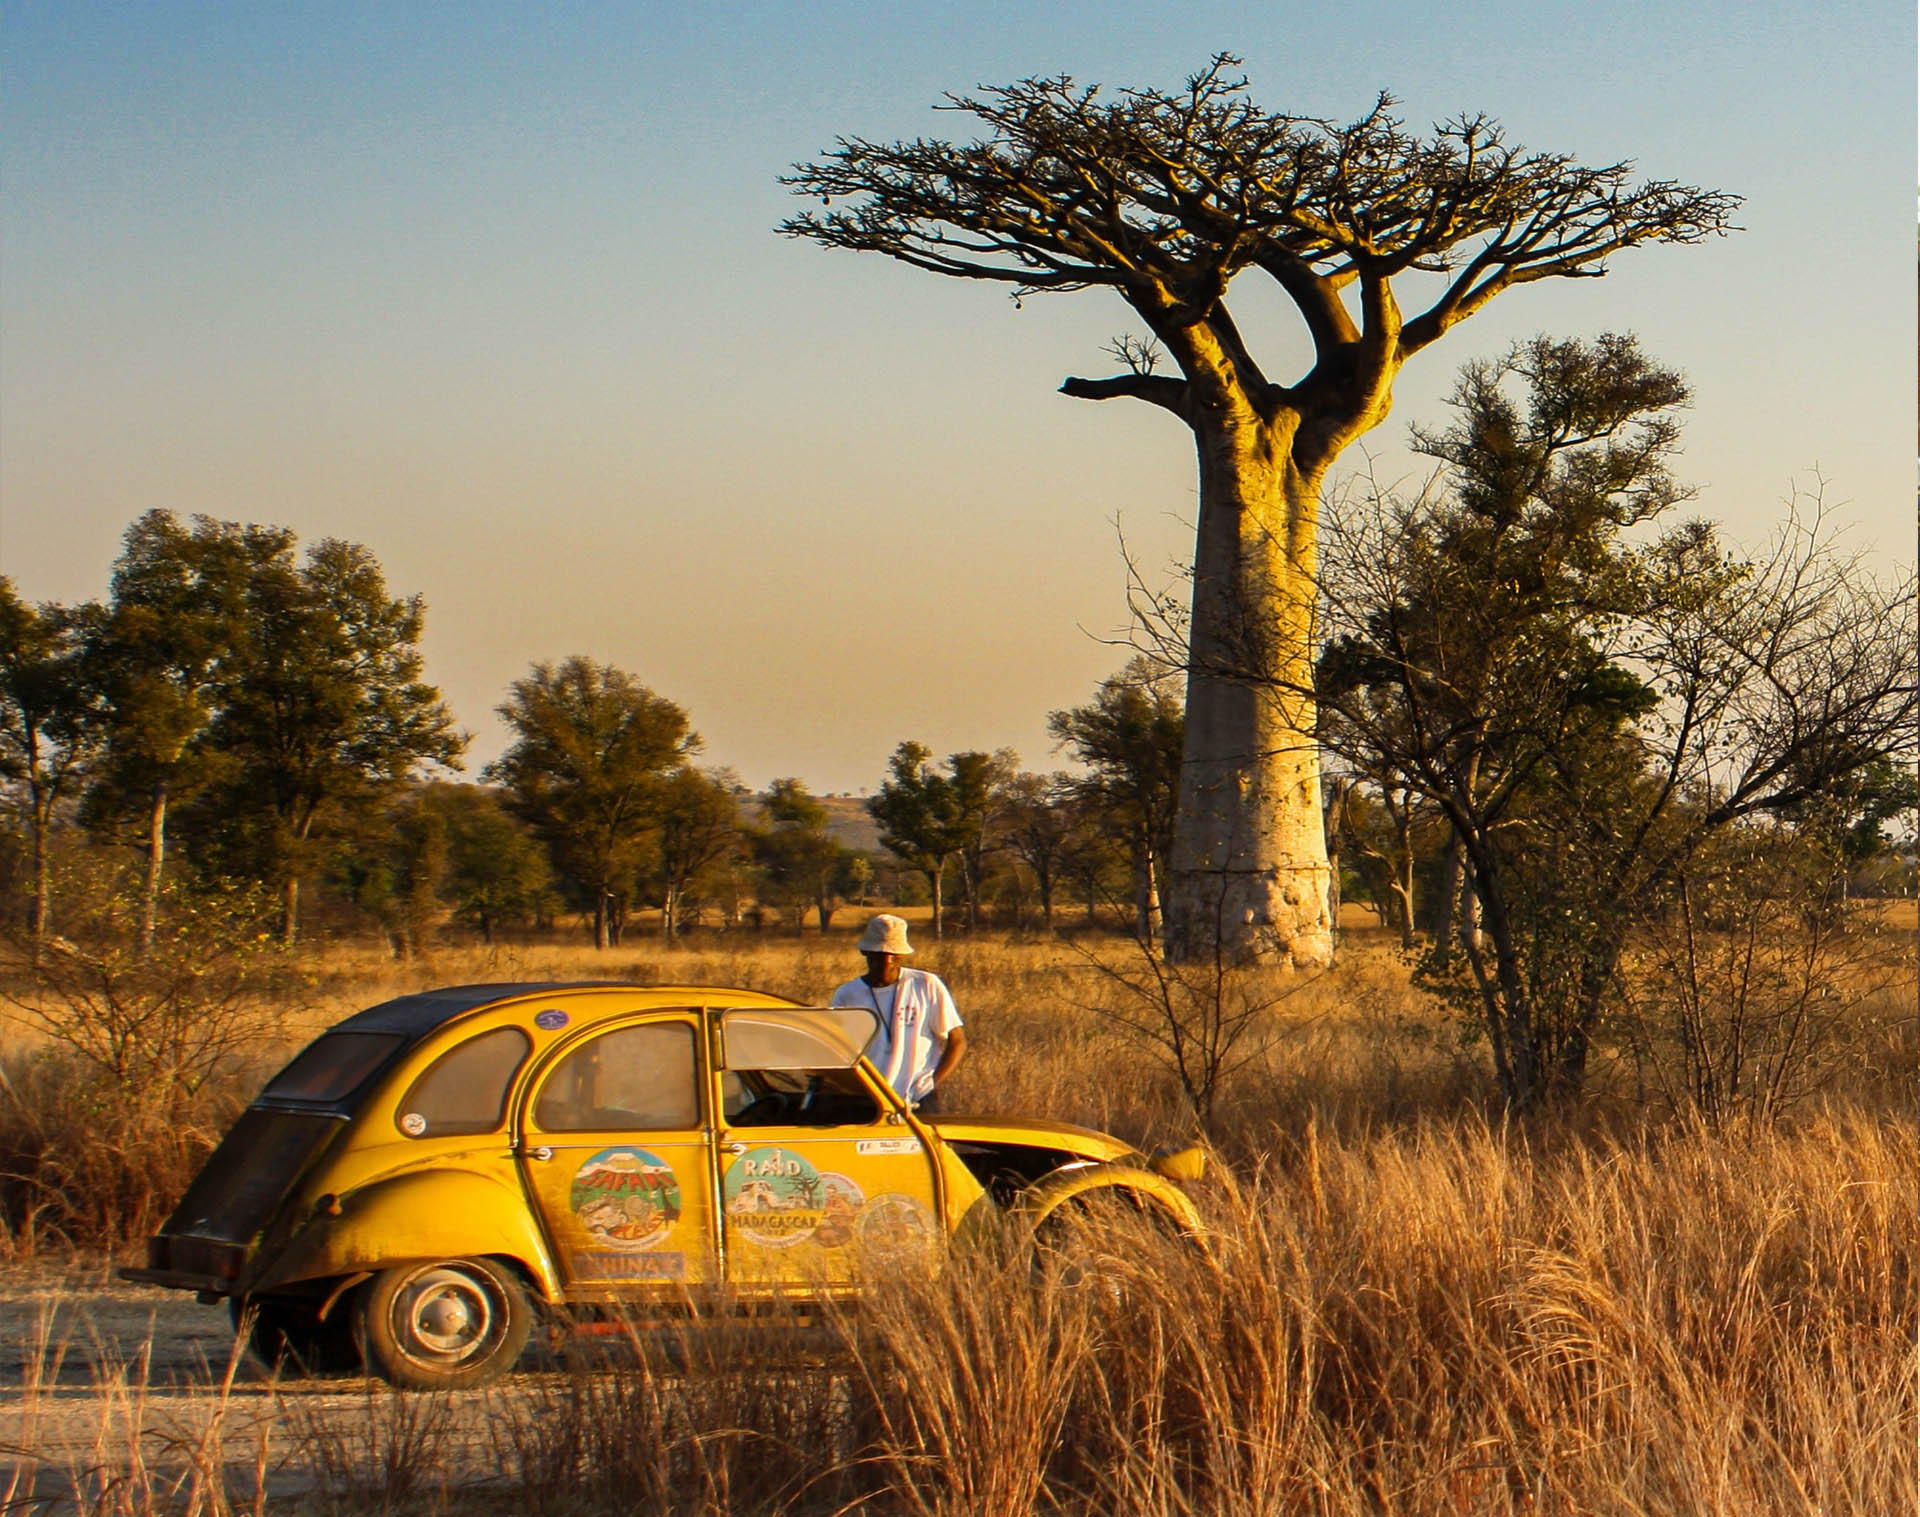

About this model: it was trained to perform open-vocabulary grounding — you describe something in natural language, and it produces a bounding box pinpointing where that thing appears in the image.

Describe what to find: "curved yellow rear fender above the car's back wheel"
[246,1169,561,1302]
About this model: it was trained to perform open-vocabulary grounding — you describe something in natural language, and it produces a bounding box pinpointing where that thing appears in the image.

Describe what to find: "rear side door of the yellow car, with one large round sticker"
[516,1010,718,1298]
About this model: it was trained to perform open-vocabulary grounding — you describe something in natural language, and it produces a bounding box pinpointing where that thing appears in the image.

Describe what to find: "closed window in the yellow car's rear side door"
[534,1022,701,1133]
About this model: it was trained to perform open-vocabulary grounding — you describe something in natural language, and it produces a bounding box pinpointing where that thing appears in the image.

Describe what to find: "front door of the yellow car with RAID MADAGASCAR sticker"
[718,1010,945,1294]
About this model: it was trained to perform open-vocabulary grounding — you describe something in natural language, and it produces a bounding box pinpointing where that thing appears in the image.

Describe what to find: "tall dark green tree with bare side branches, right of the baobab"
[1319,336,1916,1108]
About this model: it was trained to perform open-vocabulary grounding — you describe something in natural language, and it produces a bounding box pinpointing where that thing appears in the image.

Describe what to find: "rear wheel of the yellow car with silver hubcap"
[355,1260,532,1390]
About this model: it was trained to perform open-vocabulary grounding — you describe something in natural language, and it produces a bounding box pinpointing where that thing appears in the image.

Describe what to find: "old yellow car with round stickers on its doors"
[121,983,1200,1386]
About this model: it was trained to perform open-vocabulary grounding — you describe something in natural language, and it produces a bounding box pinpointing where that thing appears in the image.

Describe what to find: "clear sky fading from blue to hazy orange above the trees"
[0,0,1916,791]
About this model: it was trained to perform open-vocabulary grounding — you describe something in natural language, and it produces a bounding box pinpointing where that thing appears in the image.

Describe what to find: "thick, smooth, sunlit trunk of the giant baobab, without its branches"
[1165,413,1332,966]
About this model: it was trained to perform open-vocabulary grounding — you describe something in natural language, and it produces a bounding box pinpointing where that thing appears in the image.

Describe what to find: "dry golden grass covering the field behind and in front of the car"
[3,933,1920,1517]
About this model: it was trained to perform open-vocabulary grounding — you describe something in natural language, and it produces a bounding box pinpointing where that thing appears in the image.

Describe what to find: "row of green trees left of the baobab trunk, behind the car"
[0,511,1183,956]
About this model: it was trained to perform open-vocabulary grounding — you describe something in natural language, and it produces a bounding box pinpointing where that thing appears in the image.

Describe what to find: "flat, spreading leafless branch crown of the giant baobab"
[781,54,1740,457]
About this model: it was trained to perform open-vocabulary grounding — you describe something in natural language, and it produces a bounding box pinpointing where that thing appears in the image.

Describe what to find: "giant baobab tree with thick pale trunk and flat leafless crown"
[780,54,1740,964]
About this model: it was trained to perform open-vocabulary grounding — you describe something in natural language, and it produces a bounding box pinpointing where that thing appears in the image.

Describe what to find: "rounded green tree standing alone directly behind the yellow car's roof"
[486,657,699,949]
